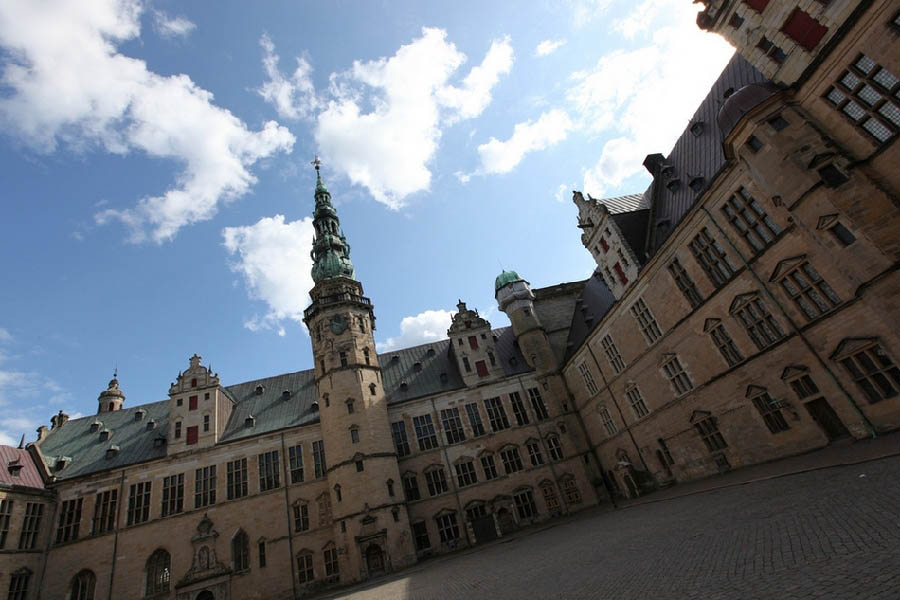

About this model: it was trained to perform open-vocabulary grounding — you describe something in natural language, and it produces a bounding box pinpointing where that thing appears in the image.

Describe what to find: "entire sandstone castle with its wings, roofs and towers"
[0,0,900,600]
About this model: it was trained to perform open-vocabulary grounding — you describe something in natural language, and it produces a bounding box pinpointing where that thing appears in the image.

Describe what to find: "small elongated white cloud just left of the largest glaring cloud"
[478,108,572,174]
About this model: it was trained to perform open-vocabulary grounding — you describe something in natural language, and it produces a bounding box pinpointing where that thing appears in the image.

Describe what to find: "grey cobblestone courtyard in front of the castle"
[331,457,900,600]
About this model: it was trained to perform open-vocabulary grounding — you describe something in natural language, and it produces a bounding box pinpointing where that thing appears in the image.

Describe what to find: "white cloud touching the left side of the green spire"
[222,215,314,335]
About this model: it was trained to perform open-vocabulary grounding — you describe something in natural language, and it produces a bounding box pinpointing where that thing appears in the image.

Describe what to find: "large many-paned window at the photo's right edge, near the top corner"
[825,54,900,144]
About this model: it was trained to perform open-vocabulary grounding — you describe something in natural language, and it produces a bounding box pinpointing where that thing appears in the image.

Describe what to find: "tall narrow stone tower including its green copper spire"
[303,158,416,580]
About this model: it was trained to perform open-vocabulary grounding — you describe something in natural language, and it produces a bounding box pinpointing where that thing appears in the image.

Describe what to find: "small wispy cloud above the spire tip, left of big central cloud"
[257,34,319,119]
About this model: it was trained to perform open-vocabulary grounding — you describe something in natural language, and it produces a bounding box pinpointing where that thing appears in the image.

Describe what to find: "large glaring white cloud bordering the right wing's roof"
[568,0,734,196]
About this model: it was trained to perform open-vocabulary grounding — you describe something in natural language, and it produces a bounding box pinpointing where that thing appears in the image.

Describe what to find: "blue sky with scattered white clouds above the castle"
[0,0,733,443]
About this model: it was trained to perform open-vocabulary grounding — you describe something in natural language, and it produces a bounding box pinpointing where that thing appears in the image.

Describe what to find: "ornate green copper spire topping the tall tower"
[311,156,354,283]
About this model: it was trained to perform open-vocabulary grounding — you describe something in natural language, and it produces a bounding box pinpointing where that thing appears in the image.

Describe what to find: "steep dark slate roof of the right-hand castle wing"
[648,53,766,255]
